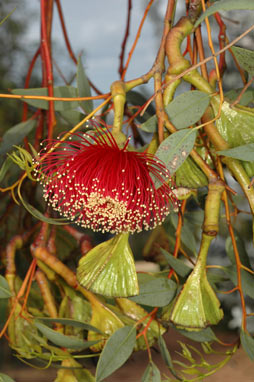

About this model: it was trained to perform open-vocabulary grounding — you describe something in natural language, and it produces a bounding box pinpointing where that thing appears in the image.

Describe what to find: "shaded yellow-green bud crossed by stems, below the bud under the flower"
[87,300,124,352]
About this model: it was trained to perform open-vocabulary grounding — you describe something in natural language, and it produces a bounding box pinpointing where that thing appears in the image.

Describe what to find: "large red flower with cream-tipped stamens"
[36,131,178,233]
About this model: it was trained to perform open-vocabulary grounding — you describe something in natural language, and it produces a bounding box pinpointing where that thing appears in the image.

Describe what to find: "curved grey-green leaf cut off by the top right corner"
[194,0,254,28]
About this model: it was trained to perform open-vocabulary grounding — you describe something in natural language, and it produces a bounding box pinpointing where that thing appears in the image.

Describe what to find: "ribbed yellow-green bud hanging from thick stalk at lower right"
[170,262,223,330]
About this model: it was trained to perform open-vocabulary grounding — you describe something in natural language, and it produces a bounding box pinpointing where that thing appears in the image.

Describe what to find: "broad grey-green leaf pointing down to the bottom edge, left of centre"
[95,326,136,382]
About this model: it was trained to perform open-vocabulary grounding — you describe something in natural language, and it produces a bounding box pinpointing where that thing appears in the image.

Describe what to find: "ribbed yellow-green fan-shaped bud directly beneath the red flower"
[77,233,139,297]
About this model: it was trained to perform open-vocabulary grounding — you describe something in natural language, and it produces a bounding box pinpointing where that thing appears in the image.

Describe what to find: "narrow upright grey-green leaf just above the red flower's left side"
[77,57,93,114]
